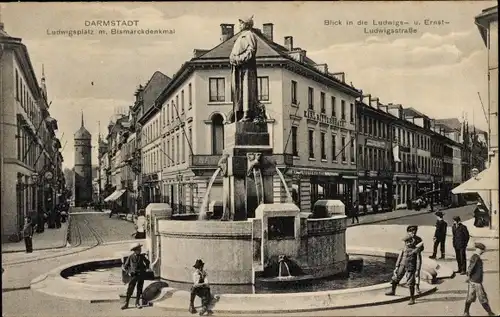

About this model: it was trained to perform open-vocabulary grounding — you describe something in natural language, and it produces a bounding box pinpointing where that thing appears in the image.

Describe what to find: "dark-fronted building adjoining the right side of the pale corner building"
[356,96,395,212]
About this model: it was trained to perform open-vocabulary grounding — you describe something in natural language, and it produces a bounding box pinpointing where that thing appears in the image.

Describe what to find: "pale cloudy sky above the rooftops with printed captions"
[0,1,496,168]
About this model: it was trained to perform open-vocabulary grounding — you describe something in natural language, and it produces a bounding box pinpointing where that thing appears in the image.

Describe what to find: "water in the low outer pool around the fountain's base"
[64,256,396,294]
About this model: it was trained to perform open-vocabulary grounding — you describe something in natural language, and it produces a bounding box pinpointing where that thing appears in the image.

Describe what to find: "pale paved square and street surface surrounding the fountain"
[2,206,500,316]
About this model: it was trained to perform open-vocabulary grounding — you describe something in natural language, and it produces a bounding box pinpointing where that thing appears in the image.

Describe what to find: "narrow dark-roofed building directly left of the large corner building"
[136,71,172,206]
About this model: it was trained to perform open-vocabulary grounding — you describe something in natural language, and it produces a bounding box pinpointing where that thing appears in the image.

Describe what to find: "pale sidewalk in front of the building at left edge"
[2,221,69,253]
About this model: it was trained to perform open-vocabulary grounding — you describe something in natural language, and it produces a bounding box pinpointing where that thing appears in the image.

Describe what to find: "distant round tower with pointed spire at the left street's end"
[73,112,92,207]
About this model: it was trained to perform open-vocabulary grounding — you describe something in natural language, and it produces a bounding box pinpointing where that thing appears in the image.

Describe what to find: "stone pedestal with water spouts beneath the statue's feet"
[223,122,276,221]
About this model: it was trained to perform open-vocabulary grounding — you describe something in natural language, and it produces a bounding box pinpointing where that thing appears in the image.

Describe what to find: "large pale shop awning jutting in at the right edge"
[451,157,498,194]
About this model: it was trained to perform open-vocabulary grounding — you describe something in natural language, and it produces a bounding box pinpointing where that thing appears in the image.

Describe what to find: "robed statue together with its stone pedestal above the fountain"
[219,17,276,221]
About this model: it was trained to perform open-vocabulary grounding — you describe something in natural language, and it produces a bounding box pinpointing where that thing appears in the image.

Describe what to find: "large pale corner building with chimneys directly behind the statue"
[154,23,360,212]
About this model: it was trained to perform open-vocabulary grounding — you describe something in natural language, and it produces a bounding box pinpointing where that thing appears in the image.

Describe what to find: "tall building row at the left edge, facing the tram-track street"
[0,22,62,237]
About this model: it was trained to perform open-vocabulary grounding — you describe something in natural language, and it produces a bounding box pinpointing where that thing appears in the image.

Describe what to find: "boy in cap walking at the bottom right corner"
[464,243,496,316]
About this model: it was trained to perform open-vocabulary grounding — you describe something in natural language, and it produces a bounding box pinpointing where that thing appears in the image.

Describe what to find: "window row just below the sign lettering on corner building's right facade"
[291,126,356,164]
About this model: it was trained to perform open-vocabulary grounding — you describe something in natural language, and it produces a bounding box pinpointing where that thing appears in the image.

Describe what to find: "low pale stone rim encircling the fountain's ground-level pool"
[30,248,446,313]
